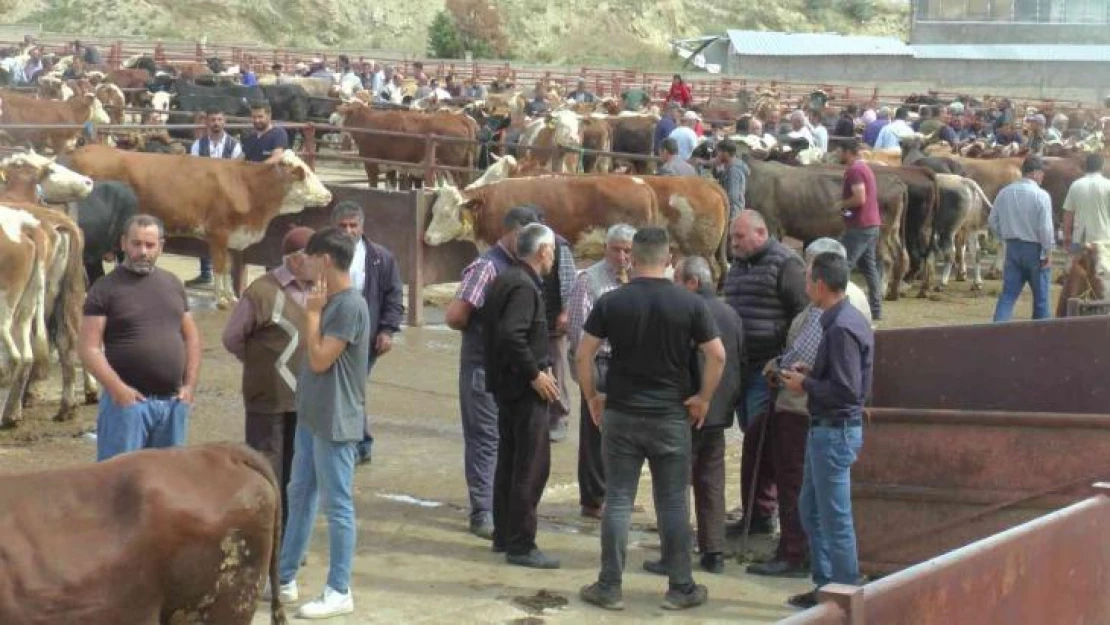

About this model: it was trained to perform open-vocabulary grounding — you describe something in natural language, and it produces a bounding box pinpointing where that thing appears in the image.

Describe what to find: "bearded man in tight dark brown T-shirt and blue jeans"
[80,214,201,461]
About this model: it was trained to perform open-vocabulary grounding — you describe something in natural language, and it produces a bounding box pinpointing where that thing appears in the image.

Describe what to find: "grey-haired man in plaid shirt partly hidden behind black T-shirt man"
[567,223,636,518]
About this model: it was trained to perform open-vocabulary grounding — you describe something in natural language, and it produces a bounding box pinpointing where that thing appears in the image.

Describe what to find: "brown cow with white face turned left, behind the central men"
[424,175,659,252]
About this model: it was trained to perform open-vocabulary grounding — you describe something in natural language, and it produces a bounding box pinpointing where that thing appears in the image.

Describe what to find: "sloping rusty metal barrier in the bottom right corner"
[779,495,1110,625]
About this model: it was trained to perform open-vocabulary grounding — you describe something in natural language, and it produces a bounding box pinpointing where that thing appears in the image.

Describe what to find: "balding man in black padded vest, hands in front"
[724,209,809,535]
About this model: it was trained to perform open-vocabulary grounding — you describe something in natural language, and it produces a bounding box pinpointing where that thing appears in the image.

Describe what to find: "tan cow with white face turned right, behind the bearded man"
[70,145,332,306]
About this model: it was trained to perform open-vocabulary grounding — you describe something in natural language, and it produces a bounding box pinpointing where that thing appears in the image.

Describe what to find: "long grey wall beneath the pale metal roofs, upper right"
[726,54,1110,103]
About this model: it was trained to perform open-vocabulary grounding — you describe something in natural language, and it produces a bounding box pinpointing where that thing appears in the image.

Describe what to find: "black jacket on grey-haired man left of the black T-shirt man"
[483,264,551,401]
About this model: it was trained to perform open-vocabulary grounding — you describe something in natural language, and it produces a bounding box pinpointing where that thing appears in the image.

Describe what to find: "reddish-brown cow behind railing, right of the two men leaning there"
[331,101,478,188]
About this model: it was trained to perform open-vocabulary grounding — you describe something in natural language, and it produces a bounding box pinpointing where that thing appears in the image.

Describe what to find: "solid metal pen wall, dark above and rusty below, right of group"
[852,316,1110,574]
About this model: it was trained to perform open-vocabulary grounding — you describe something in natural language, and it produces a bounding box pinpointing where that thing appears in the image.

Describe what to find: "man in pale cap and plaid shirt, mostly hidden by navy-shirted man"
[748,238,871,577]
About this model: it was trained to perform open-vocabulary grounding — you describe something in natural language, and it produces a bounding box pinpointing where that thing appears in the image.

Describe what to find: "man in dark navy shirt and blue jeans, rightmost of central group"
[779,252,875,608]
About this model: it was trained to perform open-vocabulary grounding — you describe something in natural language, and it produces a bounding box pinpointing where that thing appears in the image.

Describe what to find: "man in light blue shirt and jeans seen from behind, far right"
[988,157,1056,322]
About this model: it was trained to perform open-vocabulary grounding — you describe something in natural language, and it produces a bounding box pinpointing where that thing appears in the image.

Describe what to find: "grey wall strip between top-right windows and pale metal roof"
[909,22,1110,44]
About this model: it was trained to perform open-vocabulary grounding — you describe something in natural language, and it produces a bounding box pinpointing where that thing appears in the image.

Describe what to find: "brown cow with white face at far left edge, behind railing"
[0,91,109,154]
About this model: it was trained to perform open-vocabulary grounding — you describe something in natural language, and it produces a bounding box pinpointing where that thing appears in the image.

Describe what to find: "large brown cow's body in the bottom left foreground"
[0,443,285,625]
